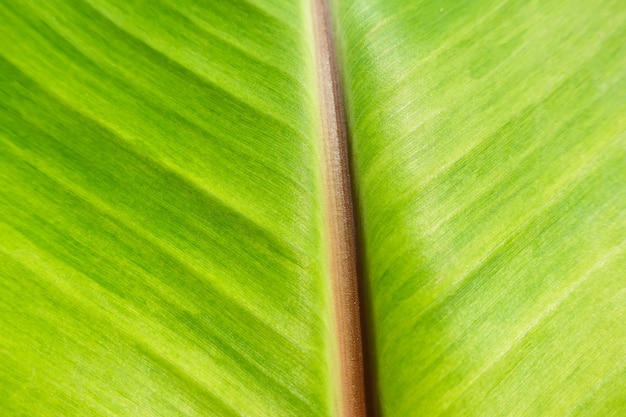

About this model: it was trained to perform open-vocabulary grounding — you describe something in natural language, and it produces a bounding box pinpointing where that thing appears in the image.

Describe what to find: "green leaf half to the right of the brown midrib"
[336,0,626,417]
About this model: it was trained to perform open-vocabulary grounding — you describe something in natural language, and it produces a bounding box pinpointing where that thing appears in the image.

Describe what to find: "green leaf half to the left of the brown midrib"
[0,0,334,416]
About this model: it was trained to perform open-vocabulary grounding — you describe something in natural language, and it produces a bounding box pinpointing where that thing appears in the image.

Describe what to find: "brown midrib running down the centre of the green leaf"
[312,0,367,417]
